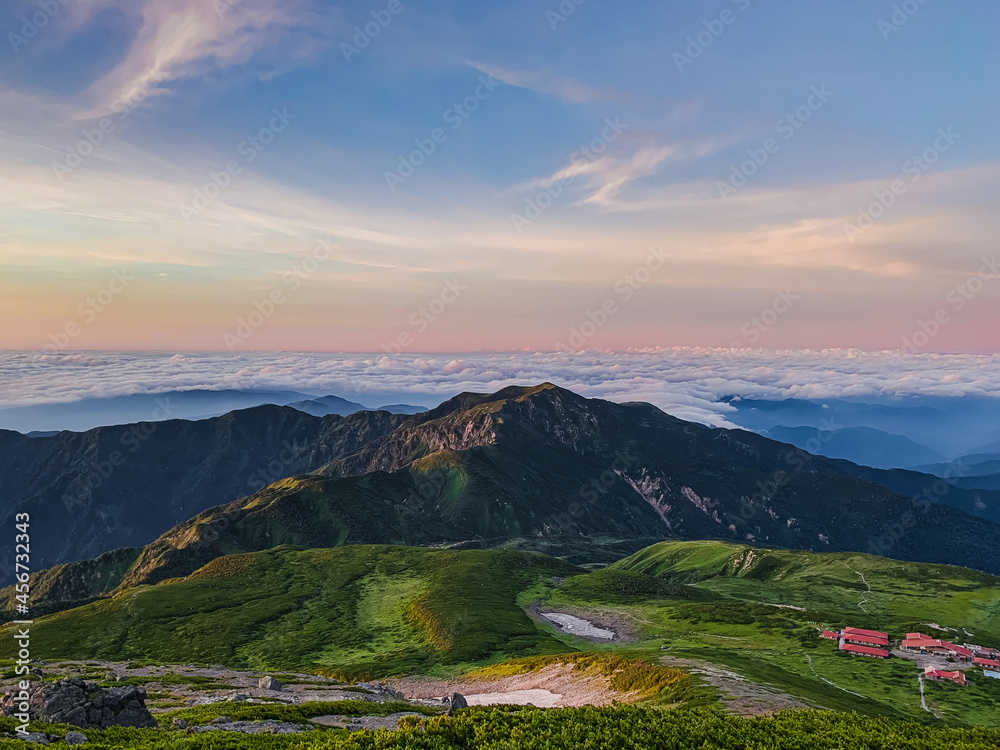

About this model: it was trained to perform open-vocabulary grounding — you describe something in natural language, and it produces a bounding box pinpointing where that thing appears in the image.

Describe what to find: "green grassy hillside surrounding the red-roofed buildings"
[547,542,1000,726]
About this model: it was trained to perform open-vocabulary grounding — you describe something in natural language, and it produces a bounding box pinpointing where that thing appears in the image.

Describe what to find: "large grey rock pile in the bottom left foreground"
[0,677,157,729]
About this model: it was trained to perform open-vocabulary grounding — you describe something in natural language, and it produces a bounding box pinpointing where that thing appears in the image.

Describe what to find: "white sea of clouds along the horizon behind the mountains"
[0,348,1000,427]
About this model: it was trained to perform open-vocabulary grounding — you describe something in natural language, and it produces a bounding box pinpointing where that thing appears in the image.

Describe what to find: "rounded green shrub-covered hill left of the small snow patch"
[0,546,580,676]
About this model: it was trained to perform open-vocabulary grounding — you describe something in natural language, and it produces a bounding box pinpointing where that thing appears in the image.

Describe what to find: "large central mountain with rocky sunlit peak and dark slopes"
[15,384,1000,616]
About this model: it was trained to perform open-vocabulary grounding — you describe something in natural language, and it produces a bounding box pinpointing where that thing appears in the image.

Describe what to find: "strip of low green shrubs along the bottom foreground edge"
[0,706,1000,750]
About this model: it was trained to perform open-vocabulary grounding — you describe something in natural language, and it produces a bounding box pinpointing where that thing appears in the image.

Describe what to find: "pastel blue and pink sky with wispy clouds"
[0,0,1000,353]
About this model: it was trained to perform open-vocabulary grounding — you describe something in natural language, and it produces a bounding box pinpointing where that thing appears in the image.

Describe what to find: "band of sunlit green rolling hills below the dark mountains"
[7,540,1000,736]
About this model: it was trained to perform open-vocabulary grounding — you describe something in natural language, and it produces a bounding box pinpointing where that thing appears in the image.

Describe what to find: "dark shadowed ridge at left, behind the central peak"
[0,406,405,583]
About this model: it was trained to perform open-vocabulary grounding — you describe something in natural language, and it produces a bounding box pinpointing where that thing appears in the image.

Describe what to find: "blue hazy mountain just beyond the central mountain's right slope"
[761,426,945,469]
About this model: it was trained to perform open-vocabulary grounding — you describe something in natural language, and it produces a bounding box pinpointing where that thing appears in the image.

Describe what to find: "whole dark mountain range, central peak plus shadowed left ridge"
[0,383,1000,604]
